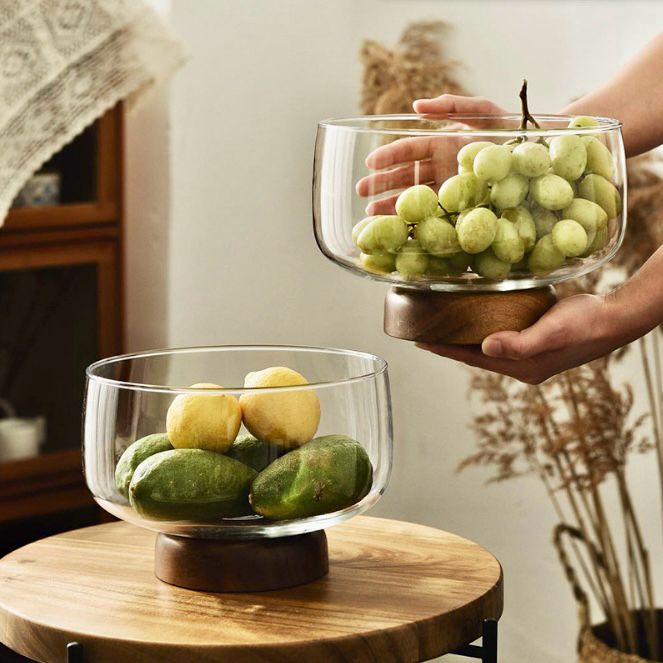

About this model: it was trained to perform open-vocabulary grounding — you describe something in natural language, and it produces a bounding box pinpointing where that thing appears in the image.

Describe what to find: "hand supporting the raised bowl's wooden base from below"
[417,295,639,384]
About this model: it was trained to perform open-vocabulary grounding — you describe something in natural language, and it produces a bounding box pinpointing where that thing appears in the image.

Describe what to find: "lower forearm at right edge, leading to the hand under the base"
[603,247,663,346]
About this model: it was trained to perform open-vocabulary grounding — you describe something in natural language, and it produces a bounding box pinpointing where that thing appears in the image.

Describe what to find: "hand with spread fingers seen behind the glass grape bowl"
[356,94,504,215]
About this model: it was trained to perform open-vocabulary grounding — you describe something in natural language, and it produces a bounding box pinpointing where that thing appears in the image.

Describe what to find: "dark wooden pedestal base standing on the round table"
[154,530,329,592]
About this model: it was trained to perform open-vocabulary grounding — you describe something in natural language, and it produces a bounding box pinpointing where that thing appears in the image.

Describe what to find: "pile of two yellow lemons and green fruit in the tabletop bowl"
[115,367,373,522]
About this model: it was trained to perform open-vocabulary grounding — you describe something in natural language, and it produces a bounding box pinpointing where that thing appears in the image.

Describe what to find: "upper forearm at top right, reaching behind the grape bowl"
[563,34,663,156]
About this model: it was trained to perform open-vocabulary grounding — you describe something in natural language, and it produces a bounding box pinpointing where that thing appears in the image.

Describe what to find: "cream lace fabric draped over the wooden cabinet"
[0,0,185,223]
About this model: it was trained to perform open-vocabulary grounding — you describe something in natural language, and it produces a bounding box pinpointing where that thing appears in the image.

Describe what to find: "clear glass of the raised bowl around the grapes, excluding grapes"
[313,113,627,292]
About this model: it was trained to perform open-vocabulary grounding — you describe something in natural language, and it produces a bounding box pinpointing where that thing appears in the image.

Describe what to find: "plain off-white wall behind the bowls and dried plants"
[128,0,663,663]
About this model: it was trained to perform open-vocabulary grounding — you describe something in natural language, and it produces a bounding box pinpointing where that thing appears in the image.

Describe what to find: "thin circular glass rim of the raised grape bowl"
[318,112,622,137]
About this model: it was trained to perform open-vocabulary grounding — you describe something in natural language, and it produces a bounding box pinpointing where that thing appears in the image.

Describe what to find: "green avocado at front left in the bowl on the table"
[129,449,257,520]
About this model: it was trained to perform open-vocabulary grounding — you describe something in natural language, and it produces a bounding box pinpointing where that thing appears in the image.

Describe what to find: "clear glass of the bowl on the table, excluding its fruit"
[84,346,392,538]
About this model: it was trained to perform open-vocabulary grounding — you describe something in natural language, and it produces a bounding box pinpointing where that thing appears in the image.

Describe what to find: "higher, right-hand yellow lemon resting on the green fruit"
[239,366,320,449]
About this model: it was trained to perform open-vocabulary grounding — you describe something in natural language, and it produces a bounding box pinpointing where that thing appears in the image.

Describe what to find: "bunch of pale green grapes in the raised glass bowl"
[352,117,622,280]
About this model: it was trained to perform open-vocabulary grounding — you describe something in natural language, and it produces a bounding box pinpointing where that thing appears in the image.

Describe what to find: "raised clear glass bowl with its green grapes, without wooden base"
[313,114,626,292]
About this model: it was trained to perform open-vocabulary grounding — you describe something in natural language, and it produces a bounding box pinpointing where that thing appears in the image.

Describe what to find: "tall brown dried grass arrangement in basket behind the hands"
[361,23,663,663]
